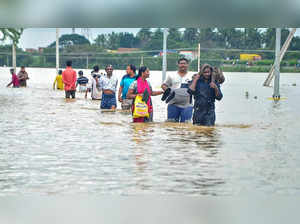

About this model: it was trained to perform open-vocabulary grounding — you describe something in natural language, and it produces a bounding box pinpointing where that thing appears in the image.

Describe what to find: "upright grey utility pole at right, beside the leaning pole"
[273,28,281,100]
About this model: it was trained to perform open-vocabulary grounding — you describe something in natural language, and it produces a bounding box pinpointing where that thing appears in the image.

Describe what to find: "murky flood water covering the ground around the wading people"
[0,68,300,196]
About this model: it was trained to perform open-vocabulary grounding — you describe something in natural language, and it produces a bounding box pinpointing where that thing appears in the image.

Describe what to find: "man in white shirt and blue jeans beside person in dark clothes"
[161,58,193,122]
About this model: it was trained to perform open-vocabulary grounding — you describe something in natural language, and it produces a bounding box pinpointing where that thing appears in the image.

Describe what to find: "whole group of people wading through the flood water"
[8,58,225,126]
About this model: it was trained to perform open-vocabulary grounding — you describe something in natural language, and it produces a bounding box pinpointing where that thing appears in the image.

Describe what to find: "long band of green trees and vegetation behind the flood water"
[0,28,300,70]
